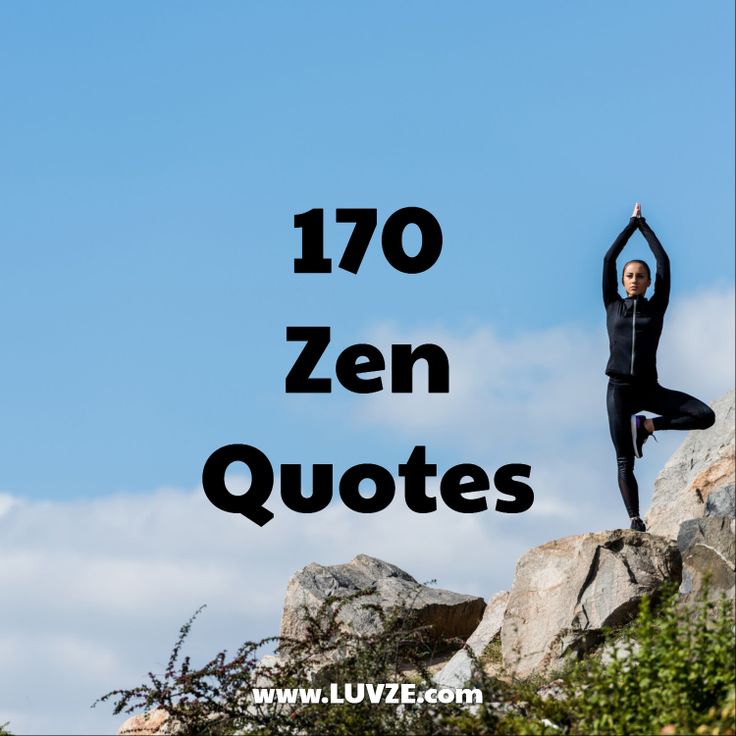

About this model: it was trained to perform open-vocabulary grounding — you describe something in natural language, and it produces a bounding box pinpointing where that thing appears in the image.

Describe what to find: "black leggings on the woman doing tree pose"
[607,378,716,517]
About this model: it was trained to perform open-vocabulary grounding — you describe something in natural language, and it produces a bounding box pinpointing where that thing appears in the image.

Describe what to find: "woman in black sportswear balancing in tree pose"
[603,202,715,532]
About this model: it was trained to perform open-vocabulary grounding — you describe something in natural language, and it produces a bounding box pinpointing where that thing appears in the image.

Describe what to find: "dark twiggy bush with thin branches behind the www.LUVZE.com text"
[95,590,504,736]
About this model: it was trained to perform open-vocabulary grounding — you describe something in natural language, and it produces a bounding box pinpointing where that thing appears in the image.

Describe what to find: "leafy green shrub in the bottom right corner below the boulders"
[500,588,736,735]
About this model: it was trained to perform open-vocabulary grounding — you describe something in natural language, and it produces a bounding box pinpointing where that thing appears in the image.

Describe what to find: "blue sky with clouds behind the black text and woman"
[0,2,734,733]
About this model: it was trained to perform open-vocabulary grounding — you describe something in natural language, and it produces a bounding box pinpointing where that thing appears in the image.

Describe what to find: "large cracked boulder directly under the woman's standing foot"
[501,529,681,677]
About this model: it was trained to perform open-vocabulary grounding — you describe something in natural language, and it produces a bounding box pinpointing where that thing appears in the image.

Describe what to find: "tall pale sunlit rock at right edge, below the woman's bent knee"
[646,390,736,539]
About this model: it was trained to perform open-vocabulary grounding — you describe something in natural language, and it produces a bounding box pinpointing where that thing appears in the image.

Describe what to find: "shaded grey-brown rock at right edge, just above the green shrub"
[677,516,736,600]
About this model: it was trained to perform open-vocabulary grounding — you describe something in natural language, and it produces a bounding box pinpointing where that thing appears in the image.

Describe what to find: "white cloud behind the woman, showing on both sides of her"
[348,290,736,456]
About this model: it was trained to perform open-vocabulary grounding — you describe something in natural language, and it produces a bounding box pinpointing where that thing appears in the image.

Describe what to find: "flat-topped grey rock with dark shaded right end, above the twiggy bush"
[280,555,485,639]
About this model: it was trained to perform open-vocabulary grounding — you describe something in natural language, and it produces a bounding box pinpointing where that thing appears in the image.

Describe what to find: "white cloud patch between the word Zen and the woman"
[359,325,603,447]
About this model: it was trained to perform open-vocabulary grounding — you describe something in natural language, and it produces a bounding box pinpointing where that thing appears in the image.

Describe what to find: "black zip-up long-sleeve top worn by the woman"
[603,217,670,381]
